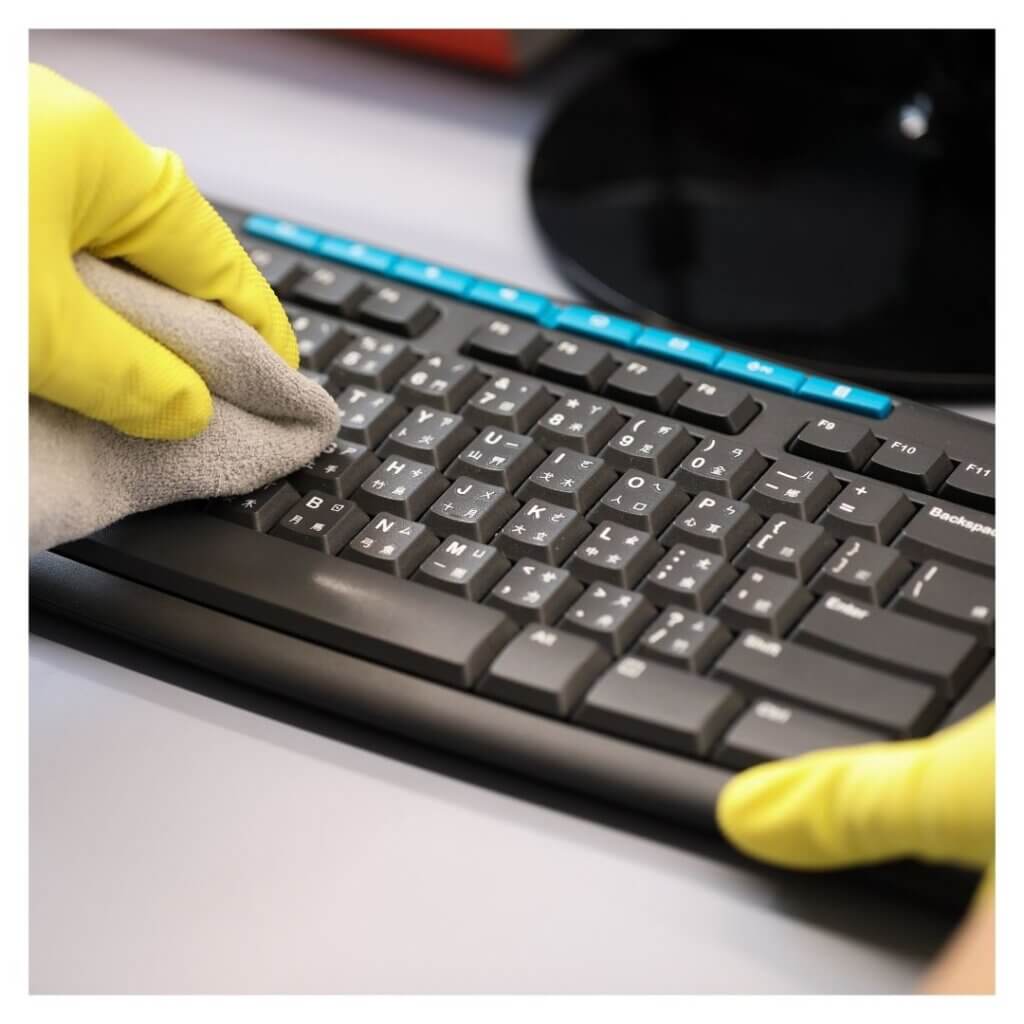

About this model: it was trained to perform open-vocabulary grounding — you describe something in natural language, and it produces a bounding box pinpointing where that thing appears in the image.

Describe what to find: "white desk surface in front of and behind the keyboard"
[30,32,966,992]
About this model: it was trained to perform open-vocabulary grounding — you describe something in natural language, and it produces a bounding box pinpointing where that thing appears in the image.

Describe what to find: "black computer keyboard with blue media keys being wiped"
[32,199,995,905]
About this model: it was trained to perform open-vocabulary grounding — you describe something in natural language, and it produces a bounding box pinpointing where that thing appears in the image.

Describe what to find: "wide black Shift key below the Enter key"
[712,630,943,737]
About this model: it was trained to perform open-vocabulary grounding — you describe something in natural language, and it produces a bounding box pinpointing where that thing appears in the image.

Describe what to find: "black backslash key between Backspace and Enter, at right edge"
[892,561,995,647]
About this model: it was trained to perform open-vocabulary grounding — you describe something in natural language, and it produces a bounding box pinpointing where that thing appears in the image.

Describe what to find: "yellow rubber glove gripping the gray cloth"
[29,65,298,440]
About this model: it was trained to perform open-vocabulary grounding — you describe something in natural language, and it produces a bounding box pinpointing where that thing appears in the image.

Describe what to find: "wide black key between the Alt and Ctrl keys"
[575,656,742,757]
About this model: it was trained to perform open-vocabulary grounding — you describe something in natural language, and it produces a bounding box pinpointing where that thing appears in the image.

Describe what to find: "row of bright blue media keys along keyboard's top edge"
[245,214,893,419]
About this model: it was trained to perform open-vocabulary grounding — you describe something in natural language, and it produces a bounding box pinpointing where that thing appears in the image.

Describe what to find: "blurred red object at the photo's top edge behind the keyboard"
[346,29,570,75]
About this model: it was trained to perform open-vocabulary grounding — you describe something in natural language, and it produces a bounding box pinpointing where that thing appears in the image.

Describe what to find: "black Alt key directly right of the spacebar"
[477,626,609,718]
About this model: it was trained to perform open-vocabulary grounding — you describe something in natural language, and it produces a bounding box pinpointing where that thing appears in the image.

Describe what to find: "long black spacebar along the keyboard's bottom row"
[58,507,516,688]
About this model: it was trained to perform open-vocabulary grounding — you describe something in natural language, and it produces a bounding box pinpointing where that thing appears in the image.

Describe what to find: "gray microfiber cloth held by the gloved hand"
[29,254,340,552]
